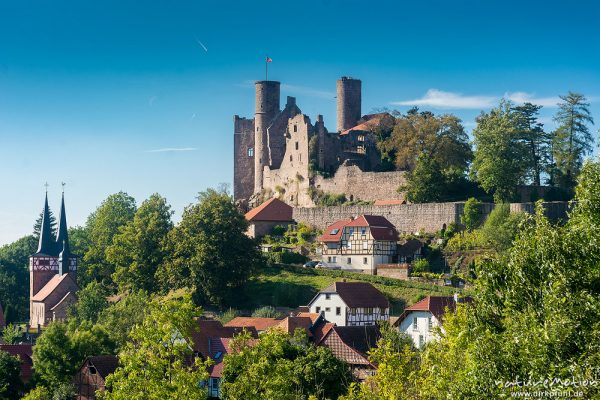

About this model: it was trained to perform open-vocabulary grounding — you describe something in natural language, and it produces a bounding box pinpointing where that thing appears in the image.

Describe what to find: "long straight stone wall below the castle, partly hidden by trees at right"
[293,202,568,233]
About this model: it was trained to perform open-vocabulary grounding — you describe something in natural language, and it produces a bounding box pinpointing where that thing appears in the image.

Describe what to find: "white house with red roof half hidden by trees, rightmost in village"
[395,295,471,349]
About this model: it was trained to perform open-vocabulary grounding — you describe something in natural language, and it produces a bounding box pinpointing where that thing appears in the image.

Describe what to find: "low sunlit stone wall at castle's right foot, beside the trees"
[314,165,406,201]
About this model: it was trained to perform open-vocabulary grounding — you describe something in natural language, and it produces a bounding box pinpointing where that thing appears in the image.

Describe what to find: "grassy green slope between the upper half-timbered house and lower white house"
[240,266,459,315]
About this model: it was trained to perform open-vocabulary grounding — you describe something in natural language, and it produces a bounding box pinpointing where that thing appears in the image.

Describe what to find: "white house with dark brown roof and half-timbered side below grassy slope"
[308,281,390,326]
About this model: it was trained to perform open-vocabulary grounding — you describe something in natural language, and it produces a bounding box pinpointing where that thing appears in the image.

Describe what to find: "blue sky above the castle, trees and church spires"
[0,0,600,244]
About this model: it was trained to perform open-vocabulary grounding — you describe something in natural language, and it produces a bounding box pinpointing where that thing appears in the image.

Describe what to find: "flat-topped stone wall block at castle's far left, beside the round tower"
[233,115,255,200]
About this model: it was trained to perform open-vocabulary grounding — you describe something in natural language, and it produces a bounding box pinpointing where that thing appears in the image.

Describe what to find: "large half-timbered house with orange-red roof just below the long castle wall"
[319,215,398,274]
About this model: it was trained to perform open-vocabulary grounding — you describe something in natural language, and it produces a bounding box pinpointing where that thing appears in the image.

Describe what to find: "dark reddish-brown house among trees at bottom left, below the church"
[73,355,119,400]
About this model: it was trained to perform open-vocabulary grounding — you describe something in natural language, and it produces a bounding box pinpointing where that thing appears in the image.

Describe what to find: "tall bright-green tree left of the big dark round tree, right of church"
[106,193,173,292]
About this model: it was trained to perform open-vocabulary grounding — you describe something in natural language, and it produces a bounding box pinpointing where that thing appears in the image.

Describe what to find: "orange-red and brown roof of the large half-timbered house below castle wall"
[319,215,398,242]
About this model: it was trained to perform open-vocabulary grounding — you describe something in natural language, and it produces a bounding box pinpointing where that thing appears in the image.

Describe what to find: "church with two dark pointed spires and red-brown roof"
[29,193,79,327]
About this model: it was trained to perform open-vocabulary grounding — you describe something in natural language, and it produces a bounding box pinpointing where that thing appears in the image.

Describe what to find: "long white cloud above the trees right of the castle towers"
[391,89,498,109]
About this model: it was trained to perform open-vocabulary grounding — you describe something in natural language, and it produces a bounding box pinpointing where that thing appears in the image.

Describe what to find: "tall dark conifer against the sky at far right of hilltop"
[553,92,594,188]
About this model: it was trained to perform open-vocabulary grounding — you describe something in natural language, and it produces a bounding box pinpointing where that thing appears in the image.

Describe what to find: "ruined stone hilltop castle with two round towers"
[233,77,405,207]
